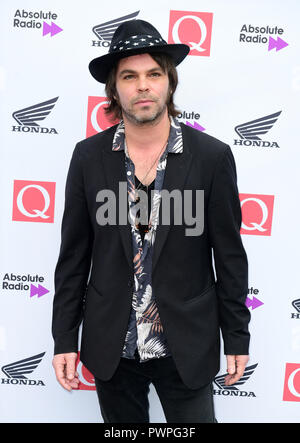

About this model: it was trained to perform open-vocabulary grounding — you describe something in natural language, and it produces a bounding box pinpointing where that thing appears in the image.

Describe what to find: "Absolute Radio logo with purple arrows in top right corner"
[239,24,288,52]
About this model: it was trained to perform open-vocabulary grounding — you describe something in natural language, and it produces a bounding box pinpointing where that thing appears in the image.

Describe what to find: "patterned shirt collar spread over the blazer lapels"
[112,116,183,156]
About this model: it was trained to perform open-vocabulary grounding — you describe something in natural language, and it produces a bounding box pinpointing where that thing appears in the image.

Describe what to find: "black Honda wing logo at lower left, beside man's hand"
[0,352,45,386]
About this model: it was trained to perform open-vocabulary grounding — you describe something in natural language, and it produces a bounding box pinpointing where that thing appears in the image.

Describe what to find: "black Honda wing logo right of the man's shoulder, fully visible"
[233,111,281,148]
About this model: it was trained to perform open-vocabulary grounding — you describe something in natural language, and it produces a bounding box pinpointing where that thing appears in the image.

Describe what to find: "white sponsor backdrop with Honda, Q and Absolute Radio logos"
[0,0,300,423]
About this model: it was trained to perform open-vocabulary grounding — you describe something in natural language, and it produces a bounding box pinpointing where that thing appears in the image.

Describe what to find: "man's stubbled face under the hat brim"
[116,54,169,125]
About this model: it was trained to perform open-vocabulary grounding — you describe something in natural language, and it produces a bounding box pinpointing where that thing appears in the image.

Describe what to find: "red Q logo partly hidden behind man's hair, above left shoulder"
[86,97,119,137]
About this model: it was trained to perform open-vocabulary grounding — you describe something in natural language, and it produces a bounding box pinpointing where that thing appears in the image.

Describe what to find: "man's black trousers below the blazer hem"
[95,357,216,423]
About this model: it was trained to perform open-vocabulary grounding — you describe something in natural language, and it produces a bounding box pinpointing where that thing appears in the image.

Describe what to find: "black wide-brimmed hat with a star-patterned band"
[89,20,190,83]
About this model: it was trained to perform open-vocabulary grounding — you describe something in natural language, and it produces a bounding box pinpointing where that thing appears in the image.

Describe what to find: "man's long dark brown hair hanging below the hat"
[104,53,180,121]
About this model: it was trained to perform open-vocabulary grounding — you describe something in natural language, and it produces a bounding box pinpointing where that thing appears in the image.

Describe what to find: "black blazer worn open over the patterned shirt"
[53,124,250,389]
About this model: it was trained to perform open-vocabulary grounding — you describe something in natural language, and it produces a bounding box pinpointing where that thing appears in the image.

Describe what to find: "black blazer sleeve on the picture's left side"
[52,144,93,354]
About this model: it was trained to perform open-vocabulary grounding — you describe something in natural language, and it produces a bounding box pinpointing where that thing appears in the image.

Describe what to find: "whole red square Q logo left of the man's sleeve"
[12,180,55,223]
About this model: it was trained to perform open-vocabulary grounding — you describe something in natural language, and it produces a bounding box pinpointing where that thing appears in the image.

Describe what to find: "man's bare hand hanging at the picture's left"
[52,352,79,391]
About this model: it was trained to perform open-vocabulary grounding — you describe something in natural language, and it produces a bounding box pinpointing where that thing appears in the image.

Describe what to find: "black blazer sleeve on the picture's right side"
[208,145,250,355]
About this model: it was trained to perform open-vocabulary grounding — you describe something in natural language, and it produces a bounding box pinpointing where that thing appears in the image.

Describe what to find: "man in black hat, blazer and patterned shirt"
[53,20,249,423]
